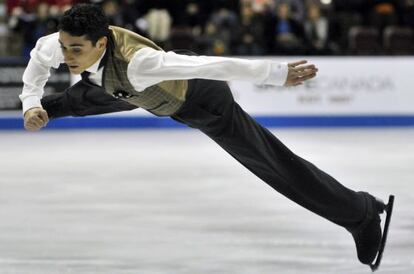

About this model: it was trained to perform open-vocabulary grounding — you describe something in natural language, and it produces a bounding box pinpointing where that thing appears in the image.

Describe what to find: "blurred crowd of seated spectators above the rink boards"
[0,0,414,57]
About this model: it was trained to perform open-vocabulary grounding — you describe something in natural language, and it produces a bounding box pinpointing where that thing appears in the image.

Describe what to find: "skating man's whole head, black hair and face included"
[59,4,109,74]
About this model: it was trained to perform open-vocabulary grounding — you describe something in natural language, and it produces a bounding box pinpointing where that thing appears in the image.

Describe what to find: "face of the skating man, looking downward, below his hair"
[59,31,107,74]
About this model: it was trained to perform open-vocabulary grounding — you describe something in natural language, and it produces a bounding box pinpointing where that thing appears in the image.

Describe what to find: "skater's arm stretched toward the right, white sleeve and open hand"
[128,48,317,91]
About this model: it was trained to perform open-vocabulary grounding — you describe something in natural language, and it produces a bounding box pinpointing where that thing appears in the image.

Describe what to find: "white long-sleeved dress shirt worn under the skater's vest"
[19,32,288,113]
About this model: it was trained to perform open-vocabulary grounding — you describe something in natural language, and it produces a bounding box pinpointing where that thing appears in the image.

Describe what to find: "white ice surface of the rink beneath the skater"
[0,128,414,274]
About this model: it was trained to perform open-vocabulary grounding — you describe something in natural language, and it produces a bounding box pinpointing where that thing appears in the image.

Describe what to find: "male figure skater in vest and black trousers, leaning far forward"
[20,4,393,269]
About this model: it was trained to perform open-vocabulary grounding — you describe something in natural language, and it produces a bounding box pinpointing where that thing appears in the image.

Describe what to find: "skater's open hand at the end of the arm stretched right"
[284,60,318,87]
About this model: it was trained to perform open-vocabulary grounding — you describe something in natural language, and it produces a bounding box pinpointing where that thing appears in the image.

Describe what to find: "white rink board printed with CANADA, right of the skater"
[230,57,414,115]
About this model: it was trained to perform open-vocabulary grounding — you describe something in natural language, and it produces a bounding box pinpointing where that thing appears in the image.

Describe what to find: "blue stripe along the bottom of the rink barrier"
[0,115,414,130]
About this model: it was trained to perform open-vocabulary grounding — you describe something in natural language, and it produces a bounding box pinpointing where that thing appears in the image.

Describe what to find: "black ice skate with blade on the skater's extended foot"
[351,195,394,272]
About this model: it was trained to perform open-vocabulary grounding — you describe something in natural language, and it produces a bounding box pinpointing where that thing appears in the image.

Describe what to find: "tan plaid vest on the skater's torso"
[102,26,188,116]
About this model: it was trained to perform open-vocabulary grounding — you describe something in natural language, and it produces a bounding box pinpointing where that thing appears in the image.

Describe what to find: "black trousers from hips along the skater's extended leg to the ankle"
[172,79,368,230]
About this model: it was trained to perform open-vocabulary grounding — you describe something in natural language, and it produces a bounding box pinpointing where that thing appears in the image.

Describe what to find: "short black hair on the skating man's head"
[58,4,109,46]
